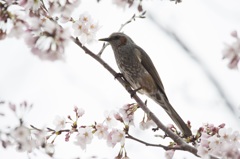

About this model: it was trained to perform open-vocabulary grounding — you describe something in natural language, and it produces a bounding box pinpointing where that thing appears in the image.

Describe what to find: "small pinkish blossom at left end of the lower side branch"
[107,129,125,147]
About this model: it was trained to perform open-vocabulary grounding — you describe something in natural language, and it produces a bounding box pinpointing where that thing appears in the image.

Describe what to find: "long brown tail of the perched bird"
[150,93,192,137]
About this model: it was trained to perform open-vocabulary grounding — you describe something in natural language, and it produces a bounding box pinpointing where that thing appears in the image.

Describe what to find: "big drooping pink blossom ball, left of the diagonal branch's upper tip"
[25,19,70,60]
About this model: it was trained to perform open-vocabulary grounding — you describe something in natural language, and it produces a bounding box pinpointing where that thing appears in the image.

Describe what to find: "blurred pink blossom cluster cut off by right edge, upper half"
[223,31,240,69]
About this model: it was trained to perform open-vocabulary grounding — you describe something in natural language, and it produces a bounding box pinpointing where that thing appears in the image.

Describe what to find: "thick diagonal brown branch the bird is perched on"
[71,37,197,156]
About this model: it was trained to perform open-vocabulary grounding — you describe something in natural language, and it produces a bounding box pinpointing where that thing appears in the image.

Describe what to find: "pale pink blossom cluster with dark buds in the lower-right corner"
[197,124,240,159]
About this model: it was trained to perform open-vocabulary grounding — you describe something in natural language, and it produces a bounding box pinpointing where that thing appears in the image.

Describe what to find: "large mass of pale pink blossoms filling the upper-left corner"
[0,0,99,60]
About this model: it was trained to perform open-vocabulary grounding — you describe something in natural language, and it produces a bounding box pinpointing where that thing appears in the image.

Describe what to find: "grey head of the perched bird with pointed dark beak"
[99,32,133,47]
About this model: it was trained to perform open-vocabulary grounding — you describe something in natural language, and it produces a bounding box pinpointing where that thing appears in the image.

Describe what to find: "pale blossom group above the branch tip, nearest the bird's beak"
[72,13,99,44]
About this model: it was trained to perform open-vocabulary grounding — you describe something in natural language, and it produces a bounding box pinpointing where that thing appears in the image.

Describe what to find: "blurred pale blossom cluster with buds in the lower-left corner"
[0,101,53,156]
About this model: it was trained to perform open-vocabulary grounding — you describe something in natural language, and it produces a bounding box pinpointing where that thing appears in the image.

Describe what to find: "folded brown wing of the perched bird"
[134,45,167,98]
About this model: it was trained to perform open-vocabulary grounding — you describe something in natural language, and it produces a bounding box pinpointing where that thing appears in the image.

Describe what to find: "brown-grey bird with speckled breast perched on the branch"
[99,32,192,137]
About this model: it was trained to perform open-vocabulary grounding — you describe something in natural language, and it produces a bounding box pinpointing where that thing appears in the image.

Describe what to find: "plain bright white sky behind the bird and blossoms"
[0,0,240,159]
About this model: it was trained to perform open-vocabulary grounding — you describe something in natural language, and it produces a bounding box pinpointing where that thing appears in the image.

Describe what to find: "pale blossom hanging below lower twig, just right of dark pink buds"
[75,127,93,150]
